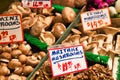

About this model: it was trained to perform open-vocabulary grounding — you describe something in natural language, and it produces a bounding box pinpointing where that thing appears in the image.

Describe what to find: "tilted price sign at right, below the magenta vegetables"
[81,8,111,31]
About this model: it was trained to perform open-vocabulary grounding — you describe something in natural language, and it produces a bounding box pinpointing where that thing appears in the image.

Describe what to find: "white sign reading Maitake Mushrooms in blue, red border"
[48,45,87,77]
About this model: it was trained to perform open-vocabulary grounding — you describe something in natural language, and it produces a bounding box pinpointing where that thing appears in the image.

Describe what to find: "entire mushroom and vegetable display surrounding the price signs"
[0,0,120,80]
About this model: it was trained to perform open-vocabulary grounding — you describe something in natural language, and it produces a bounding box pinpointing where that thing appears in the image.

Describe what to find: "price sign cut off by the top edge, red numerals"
[22,0,52,8]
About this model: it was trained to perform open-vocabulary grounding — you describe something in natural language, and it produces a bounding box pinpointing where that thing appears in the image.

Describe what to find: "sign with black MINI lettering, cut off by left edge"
[0,14,23,43]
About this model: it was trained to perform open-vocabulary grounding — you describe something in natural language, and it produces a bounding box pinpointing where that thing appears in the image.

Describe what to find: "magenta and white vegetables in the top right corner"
[87,0,120,18]
